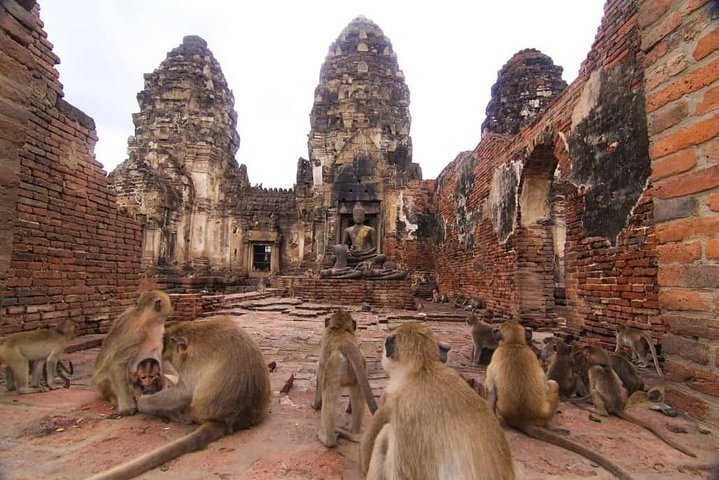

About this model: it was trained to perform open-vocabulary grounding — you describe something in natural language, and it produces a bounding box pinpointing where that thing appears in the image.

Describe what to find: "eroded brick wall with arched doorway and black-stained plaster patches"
[435,0,664,338]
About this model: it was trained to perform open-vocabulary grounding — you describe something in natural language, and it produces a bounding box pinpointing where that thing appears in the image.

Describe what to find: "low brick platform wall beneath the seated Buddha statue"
[272,276,414,309]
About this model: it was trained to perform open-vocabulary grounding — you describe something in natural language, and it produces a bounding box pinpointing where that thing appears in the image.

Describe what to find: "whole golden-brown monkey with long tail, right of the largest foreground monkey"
[486,321,631,479]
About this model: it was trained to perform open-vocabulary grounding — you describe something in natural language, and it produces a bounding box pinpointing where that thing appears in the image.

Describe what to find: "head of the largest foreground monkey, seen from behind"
[382,322,440,374]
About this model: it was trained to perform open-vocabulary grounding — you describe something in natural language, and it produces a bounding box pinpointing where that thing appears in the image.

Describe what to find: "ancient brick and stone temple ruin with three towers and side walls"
[0,0,719,423]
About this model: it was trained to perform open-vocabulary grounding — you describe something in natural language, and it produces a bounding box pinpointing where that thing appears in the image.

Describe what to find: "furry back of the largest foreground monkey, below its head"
[390,365,514,480]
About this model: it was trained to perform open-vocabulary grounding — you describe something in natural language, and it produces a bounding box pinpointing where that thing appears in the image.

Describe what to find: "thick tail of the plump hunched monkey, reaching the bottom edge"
[87,422,225,480]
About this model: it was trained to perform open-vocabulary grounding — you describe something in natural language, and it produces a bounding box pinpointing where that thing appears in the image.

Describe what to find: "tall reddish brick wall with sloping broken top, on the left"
[0,0,140,333]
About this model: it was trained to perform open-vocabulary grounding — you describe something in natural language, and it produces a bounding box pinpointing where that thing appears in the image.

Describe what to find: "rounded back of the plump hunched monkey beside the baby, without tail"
[168,317,272,430]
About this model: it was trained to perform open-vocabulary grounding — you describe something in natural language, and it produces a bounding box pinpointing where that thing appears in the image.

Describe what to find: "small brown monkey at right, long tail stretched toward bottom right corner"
[582,345,696,457]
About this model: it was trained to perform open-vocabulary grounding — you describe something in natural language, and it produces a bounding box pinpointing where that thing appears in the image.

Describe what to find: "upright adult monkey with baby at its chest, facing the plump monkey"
[92,290,172,415]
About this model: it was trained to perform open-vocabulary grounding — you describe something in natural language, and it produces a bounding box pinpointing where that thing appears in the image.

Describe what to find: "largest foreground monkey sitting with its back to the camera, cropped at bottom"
[361,322,515,480]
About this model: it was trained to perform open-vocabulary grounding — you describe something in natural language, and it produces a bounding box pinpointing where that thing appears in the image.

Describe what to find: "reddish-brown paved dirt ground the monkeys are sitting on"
[0,299,719,480]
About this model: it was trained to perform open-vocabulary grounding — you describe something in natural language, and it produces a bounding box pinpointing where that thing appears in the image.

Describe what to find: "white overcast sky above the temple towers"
[39,0,604,187]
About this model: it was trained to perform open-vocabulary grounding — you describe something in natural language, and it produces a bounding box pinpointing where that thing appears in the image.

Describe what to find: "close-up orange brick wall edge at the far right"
[638,0,719,425]
